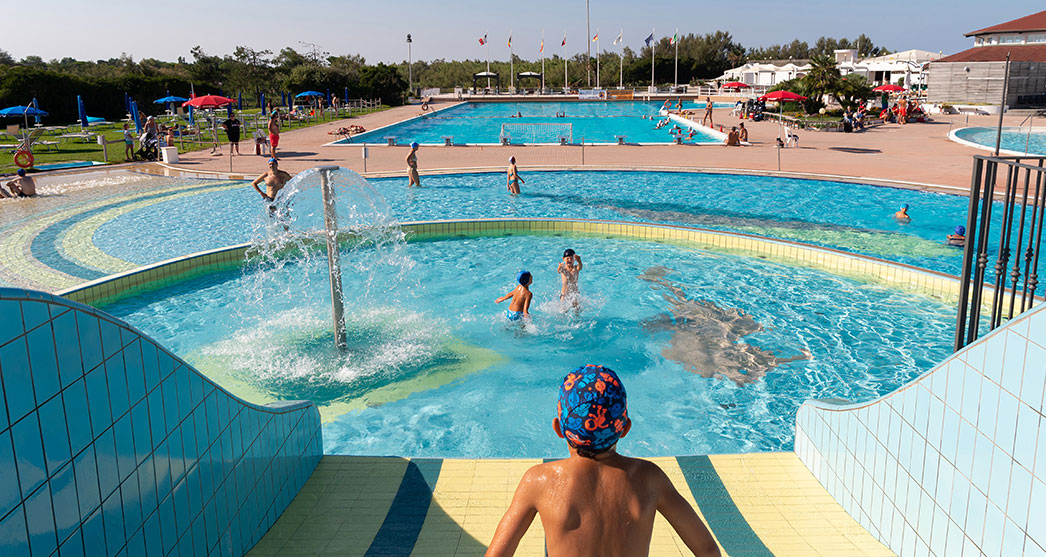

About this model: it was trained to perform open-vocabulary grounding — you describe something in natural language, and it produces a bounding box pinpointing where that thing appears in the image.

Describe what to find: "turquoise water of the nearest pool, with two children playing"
[105,237,954,458]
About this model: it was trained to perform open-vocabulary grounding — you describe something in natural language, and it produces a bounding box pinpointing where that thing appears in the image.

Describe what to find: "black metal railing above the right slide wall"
[954,155,1046,350]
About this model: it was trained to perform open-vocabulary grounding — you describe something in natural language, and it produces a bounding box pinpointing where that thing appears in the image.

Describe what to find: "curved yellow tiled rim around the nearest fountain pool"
[58,218,995,305]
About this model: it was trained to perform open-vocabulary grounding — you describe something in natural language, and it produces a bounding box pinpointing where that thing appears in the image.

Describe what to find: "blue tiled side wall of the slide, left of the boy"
[0,288,322,557]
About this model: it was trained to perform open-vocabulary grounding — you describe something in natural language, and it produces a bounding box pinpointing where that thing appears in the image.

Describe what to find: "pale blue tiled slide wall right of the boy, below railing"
[795,304,1046,556]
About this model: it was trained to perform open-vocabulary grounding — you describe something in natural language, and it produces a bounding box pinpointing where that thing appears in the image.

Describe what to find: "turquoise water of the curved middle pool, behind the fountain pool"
[94,169,974,274]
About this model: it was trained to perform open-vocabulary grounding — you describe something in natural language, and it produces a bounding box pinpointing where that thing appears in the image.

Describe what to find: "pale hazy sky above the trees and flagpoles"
[8,0,1044,63]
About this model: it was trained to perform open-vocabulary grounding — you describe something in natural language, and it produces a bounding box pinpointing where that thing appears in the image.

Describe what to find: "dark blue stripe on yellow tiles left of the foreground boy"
[366,459,444,557]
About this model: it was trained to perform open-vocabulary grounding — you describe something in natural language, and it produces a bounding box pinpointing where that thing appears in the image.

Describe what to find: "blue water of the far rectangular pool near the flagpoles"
[336,101,732,145]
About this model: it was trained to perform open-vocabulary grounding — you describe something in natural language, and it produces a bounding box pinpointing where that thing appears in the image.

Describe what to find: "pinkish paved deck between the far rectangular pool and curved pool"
[177,101,1020,189]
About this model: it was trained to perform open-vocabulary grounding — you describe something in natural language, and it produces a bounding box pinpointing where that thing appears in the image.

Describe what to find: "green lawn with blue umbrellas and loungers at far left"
[0,105,389,175]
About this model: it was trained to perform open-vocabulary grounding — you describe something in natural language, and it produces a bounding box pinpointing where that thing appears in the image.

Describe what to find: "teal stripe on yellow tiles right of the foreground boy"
[676,456,773,557]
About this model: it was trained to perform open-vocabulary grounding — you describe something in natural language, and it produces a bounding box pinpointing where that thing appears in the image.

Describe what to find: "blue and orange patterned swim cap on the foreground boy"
[556,365,629,452]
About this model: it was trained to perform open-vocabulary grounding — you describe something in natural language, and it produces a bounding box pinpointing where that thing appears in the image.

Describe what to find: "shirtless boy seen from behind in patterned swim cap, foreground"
[486,366,720,556]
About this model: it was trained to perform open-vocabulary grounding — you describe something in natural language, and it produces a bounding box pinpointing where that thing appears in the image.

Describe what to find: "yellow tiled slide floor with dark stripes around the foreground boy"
[249,452,893,557]
